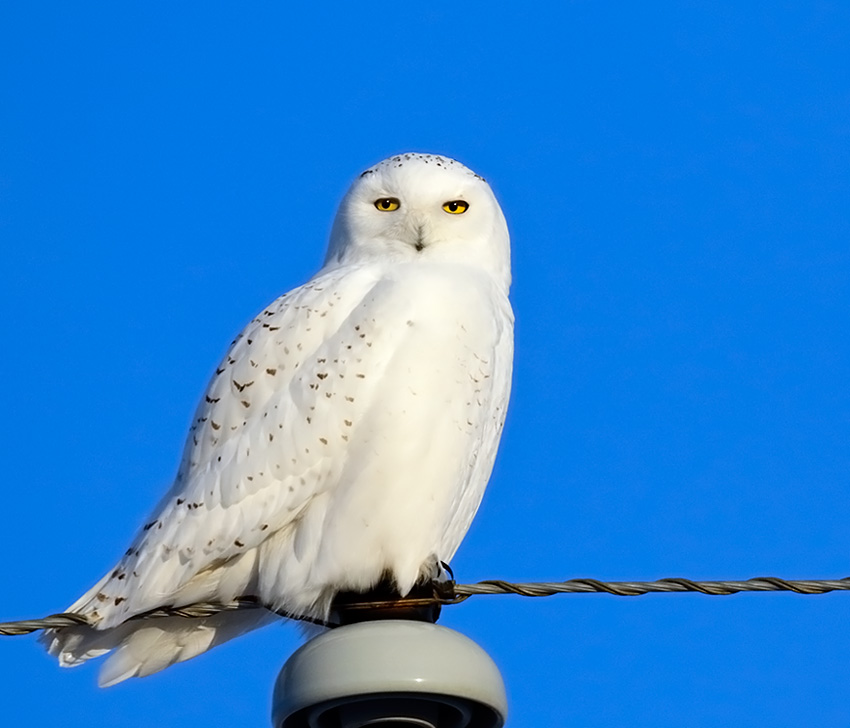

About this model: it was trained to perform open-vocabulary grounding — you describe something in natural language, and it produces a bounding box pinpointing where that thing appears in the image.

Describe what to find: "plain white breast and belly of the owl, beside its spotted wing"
[304,266,512,586]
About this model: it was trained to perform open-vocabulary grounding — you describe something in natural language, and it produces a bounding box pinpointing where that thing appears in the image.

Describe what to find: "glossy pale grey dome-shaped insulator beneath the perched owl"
[272,620,508,728]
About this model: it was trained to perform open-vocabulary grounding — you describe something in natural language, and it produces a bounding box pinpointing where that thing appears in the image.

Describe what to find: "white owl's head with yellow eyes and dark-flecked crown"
[325,153,510,287]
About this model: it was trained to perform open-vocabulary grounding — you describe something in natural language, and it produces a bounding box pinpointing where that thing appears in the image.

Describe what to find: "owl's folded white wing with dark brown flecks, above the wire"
[70,268,386,629]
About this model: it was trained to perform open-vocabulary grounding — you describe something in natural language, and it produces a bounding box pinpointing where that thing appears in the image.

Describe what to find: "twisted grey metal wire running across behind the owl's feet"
[0,576,850,636]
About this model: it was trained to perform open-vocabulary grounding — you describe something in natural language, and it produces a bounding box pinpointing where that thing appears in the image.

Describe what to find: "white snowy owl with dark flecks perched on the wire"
[43,153,513,685]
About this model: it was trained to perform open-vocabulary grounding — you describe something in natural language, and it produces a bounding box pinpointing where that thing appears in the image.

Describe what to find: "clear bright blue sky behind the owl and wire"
[0,1,850,728]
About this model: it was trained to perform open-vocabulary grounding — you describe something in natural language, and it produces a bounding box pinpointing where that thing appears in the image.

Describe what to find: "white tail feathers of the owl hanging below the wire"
[41,609,275,687]
